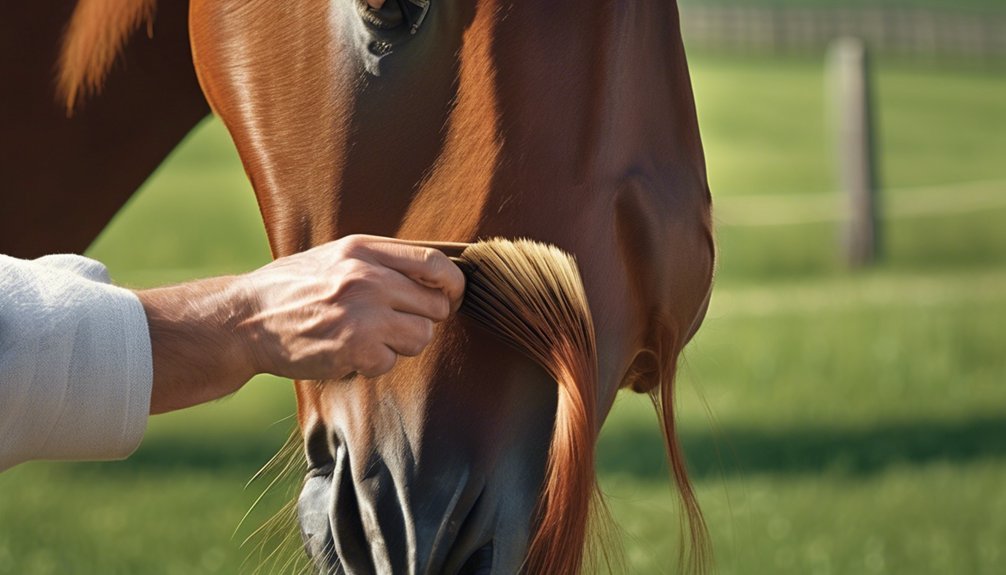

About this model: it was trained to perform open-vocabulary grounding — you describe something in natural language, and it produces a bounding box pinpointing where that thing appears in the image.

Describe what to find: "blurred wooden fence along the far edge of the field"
[681,6,1006,59]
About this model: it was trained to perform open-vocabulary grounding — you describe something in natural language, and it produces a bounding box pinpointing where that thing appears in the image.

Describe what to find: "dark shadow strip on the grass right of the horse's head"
[598,417,1006,481]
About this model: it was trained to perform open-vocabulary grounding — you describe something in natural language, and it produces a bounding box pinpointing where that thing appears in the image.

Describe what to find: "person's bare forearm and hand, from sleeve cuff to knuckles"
[137,235,465,413]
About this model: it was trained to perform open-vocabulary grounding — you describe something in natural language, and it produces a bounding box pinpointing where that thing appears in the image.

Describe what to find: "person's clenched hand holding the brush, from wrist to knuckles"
[236,235,465,379]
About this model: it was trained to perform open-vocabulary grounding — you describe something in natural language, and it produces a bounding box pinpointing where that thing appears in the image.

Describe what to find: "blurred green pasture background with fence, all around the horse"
[0,0,1006,575]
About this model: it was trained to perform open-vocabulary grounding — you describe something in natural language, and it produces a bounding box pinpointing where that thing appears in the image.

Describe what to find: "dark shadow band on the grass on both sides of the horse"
[64,417,1006,481]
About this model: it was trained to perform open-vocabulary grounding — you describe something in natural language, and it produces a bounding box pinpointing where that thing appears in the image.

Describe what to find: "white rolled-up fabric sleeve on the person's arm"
[0,255,153,470]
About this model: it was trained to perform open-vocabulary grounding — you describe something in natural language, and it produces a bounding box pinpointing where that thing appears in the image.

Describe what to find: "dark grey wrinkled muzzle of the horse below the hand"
[298,448,493,575]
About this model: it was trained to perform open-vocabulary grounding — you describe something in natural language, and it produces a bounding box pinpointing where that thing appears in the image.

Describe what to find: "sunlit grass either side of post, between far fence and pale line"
[691,55,1006,197]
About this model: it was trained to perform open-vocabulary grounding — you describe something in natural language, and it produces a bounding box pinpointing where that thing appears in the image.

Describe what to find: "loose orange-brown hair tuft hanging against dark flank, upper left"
[56,0,157,112]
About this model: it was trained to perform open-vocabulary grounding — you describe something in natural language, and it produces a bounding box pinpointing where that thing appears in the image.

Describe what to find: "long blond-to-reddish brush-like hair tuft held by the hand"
[459,239,600,575]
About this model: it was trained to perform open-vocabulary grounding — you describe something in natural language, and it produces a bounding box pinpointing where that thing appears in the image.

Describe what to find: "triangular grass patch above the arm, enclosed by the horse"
[89,122,270,285]
